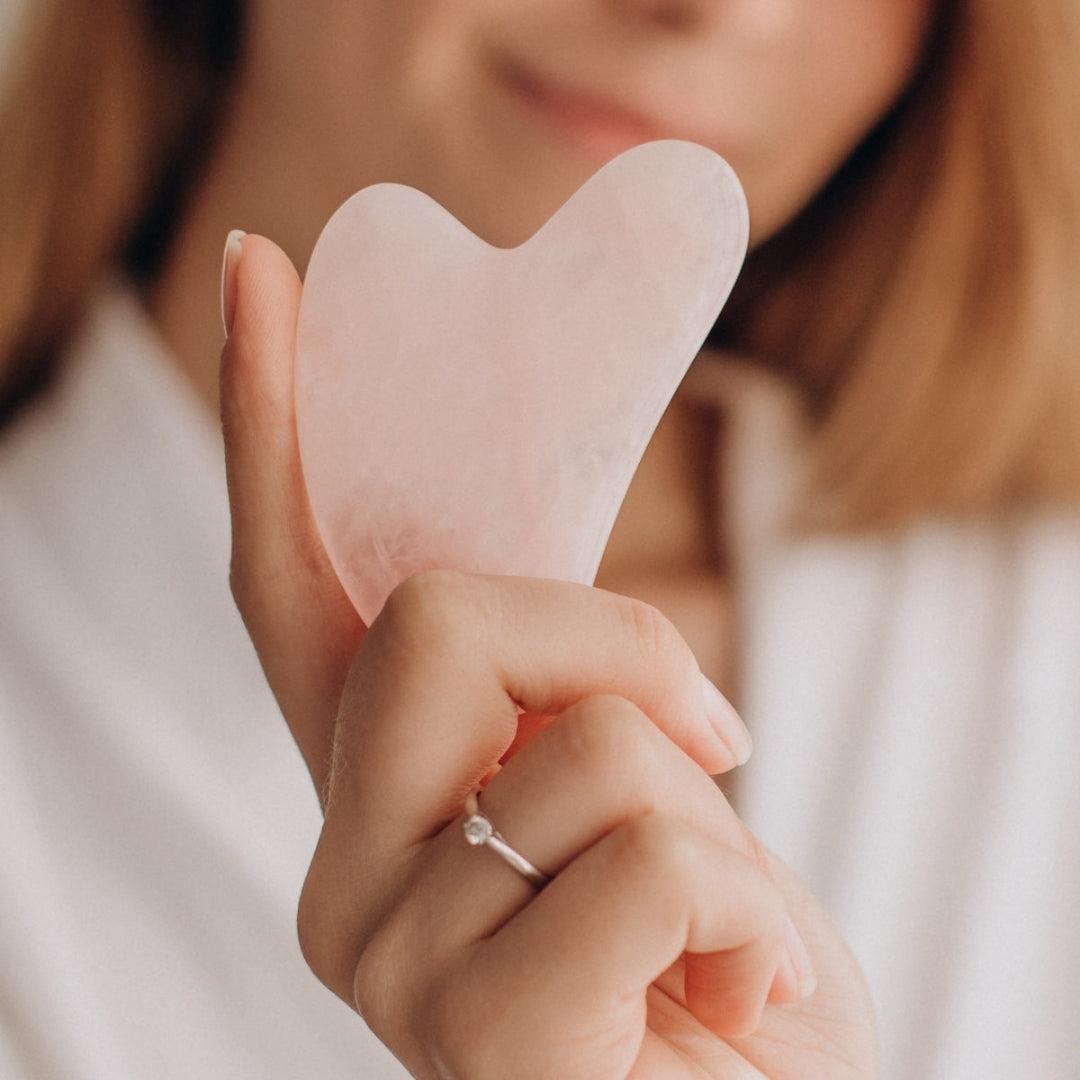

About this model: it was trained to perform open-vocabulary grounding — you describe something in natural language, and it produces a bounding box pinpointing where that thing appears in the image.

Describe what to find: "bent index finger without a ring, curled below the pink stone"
[324,571,737,850]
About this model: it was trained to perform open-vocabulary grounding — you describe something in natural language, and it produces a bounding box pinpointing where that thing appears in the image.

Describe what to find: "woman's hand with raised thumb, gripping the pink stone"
[222,237,875,1080]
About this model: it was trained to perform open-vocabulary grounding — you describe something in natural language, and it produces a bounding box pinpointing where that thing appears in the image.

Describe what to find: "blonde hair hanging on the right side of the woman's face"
[719,0,1080,529]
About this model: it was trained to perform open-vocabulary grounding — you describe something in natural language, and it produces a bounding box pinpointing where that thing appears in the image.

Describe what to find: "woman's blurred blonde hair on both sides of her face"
[0,0,1080,528]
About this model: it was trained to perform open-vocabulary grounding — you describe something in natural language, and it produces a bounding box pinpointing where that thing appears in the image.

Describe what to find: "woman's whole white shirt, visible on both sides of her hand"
[0,295,1080,1080]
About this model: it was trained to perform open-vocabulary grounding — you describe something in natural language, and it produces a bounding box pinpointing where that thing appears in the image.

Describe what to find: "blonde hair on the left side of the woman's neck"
[0,0,239,422]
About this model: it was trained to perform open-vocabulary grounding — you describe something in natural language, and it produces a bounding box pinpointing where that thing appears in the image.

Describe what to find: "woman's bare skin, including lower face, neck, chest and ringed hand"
[177,0,930,1080]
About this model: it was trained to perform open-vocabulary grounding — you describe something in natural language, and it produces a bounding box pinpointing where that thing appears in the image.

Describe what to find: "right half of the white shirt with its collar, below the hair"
[720,362,1080,1080]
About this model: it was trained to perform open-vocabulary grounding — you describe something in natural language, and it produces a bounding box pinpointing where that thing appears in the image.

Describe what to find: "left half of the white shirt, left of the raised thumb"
[0,295,406,1080]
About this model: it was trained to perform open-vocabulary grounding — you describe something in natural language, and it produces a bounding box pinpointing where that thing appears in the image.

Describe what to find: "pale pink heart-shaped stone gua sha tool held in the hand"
[296,141,747,623]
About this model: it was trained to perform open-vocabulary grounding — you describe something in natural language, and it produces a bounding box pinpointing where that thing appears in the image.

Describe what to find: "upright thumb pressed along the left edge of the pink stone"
[221,233,364,792]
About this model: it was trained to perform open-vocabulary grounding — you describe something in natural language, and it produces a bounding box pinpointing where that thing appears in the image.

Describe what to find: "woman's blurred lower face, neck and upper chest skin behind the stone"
[151,0,932,690]
